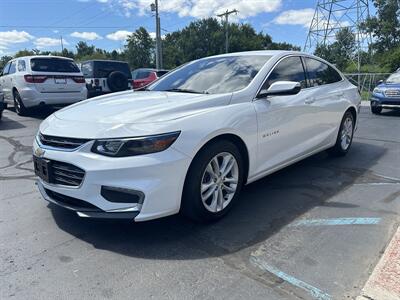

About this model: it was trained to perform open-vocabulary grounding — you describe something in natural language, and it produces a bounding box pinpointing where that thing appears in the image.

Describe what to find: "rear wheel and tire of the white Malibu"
[328,111,355,156]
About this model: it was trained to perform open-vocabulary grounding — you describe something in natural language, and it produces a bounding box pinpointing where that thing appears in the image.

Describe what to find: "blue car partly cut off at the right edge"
[371,73,400,114]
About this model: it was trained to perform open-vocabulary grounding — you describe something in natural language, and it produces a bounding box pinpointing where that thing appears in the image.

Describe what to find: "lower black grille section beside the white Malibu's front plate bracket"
[50,161,85,186]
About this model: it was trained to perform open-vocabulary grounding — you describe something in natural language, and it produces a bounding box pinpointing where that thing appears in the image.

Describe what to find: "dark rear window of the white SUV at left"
[31,58,80,73]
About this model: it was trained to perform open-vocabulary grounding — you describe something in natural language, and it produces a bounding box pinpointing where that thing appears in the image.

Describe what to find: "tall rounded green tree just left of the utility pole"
[124,27,154,68]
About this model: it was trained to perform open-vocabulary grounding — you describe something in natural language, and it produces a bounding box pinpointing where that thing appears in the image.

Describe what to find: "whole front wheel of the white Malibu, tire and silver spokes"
[181,140,244,223]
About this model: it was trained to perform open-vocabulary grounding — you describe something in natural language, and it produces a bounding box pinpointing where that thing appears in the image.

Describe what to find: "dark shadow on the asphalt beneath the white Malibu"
[49,142,386,260]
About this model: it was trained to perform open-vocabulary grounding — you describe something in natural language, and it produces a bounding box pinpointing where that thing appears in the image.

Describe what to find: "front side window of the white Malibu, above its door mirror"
[262,56,307,90]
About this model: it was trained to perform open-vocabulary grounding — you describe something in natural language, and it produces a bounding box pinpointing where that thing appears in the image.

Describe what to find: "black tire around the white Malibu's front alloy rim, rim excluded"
[181,140,244,222]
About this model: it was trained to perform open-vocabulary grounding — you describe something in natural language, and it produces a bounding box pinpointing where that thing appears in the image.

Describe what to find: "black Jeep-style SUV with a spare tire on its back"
[81,60,132,98]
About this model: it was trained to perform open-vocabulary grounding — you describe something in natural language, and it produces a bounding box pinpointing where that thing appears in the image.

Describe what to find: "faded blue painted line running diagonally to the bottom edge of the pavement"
[250,255,332,300]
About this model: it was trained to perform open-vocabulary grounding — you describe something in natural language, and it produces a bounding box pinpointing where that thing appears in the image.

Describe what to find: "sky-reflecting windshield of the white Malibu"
[148,55,272,94]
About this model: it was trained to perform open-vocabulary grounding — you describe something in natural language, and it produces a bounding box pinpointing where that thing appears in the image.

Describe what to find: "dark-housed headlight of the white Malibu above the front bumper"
[92,131,181,157]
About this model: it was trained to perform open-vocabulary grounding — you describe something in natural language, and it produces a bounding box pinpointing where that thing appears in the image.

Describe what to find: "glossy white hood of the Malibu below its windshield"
[55,91,231,124]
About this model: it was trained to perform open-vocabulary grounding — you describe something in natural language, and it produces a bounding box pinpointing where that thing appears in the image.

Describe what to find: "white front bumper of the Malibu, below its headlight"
[33,140,191,221]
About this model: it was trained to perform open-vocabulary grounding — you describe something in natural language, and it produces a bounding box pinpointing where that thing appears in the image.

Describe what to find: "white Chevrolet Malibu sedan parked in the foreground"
[33,51,360,222]
